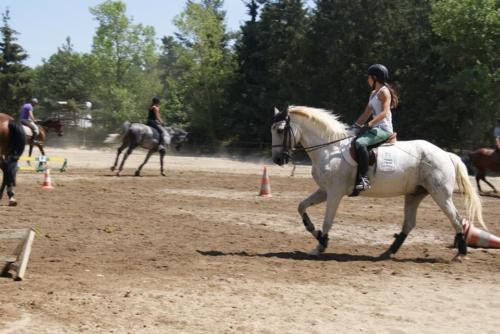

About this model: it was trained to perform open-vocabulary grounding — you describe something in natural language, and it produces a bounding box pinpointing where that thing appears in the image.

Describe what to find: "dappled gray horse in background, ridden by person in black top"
[109,122,188,176]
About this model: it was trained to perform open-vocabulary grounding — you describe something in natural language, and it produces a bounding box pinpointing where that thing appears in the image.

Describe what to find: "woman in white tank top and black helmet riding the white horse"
[354,64,399,191]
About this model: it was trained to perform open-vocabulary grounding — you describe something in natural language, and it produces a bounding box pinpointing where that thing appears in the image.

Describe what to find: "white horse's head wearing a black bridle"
[271,107,296,166]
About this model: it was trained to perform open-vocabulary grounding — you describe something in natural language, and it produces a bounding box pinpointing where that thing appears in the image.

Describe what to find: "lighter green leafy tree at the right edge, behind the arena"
[431,0,500,146]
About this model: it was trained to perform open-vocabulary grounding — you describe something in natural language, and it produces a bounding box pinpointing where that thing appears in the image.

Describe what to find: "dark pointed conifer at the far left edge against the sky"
[0,10,31,115]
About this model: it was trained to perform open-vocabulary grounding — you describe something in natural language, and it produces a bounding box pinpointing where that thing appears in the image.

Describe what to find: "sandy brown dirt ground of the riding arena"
[0,149,500,334]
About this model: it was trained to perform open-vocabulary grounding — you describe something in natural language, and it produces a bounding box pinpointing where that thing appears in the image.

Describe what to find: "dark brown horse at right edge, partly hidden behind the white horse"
[462,148,500,193]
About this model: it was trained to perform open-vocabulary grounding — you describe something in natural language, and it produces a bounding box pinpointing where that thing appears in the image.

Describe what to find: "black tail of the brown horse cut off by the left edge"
[4,120,26,186]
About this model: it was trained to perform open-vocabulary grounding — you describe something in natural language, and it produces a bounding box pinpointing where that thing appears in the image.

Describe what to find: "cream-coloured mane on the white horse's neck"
[288,106,347,140]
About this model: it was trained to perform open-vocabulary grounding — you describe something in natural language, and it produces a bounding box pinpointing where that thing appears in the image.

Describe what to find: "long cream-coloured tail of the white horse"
[449,153,488,230]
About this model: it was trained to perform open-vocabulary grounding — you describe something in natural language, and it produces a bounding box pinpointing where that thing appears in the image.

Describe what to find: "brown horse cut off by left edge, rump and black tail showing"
[0,113,26,206]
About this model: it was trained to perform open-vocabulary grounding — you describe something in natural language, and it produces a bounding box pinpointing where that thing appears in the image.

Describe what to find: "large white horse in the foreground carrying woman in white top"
[271,106,486,258]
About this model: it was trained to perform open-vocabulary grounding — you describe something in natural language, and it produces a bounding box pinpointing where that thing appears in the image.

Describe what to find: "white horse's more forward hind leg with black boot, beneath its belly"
[380,188,428,258]
